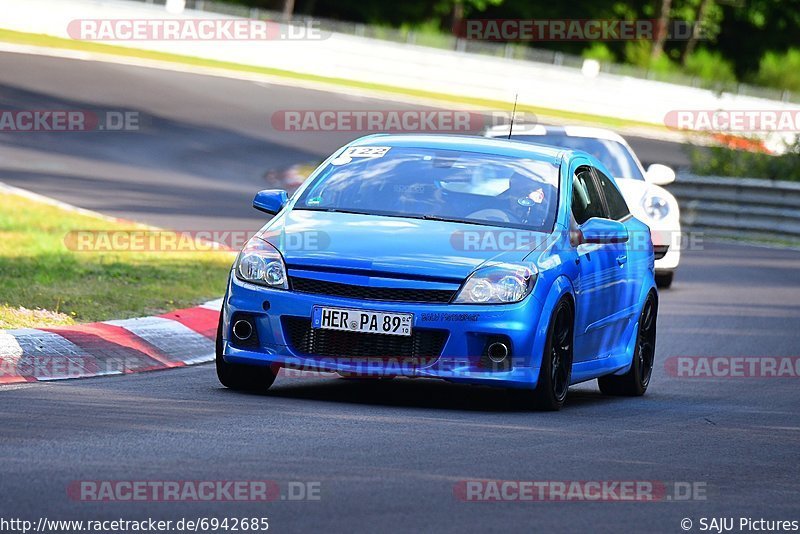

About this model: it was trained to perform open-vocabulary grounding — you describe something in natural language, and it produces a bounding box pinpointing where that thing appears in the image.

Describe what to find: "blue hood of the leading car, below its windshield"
[259,210,547,282]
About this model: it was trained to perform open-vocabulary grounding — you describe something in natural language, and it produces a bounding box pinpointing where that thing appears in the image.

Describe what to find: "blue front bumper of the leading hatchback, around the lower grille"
[222,276,544,388]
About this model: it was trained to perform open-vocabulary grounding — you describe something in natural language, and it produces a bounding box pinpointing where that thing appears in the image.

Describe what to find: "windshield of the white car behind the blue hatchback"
[514,133,644,180]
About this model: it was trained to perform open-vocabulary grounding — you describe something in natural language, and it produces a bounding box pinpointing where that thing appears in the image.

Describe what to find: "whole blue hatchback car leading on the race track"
[216,135,658,410]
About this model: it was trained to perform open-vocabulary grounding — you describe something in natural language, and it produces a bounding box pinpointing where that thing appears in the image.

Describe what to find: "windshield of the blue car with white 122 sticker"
[294,146,558,232]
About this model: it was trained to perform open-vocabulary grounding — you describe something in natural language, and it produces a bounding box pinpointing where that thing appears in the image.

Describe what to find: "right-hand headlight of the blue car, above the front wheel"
[453,263,538,304]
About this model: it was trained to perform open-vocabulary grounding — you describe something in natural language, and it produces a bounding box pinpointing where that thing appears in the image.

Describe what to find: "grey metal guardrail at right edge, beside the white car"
[667,174,800,243]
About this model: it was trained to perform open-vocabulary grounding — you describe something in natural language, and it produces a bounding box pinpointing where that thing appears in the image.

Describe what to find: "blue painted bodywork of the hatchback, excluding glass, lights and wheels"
[222,135,656,388]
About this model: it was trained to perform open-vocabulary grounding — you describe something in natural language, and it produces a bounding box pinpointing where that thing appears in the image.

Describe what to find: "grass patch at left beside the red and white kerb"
[0,193,234,328]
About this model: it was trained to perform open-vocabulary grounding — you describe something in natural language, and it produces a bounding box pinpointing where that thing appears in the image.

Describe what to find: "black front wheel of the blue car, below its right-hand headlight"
[514,299,575,412]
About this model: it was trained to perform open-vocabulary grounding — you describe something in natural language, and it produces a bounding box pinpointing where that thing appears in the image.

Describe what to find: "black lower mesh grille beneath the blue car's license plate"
[282,317,448,362]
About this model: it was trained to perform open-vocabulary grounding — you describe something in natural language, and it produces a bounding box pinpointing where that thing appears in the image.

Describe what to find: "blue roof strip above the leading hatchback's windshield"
[348,134,577,165]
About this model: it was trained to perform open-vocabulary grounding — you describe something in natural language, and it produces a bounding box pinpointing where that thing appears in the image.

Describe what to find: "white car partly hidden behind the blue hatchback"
[485,124,681,288]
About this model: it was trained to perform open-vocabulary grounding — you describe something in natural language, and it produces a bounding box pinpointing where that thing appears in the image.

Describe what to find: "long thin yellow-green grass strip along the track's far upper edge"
[0,29,667,131]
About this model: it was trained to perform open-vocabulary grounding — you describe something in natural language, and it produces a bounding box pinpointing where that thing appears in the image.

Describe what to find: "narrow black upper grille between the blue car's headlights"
[289,276,456,303]
